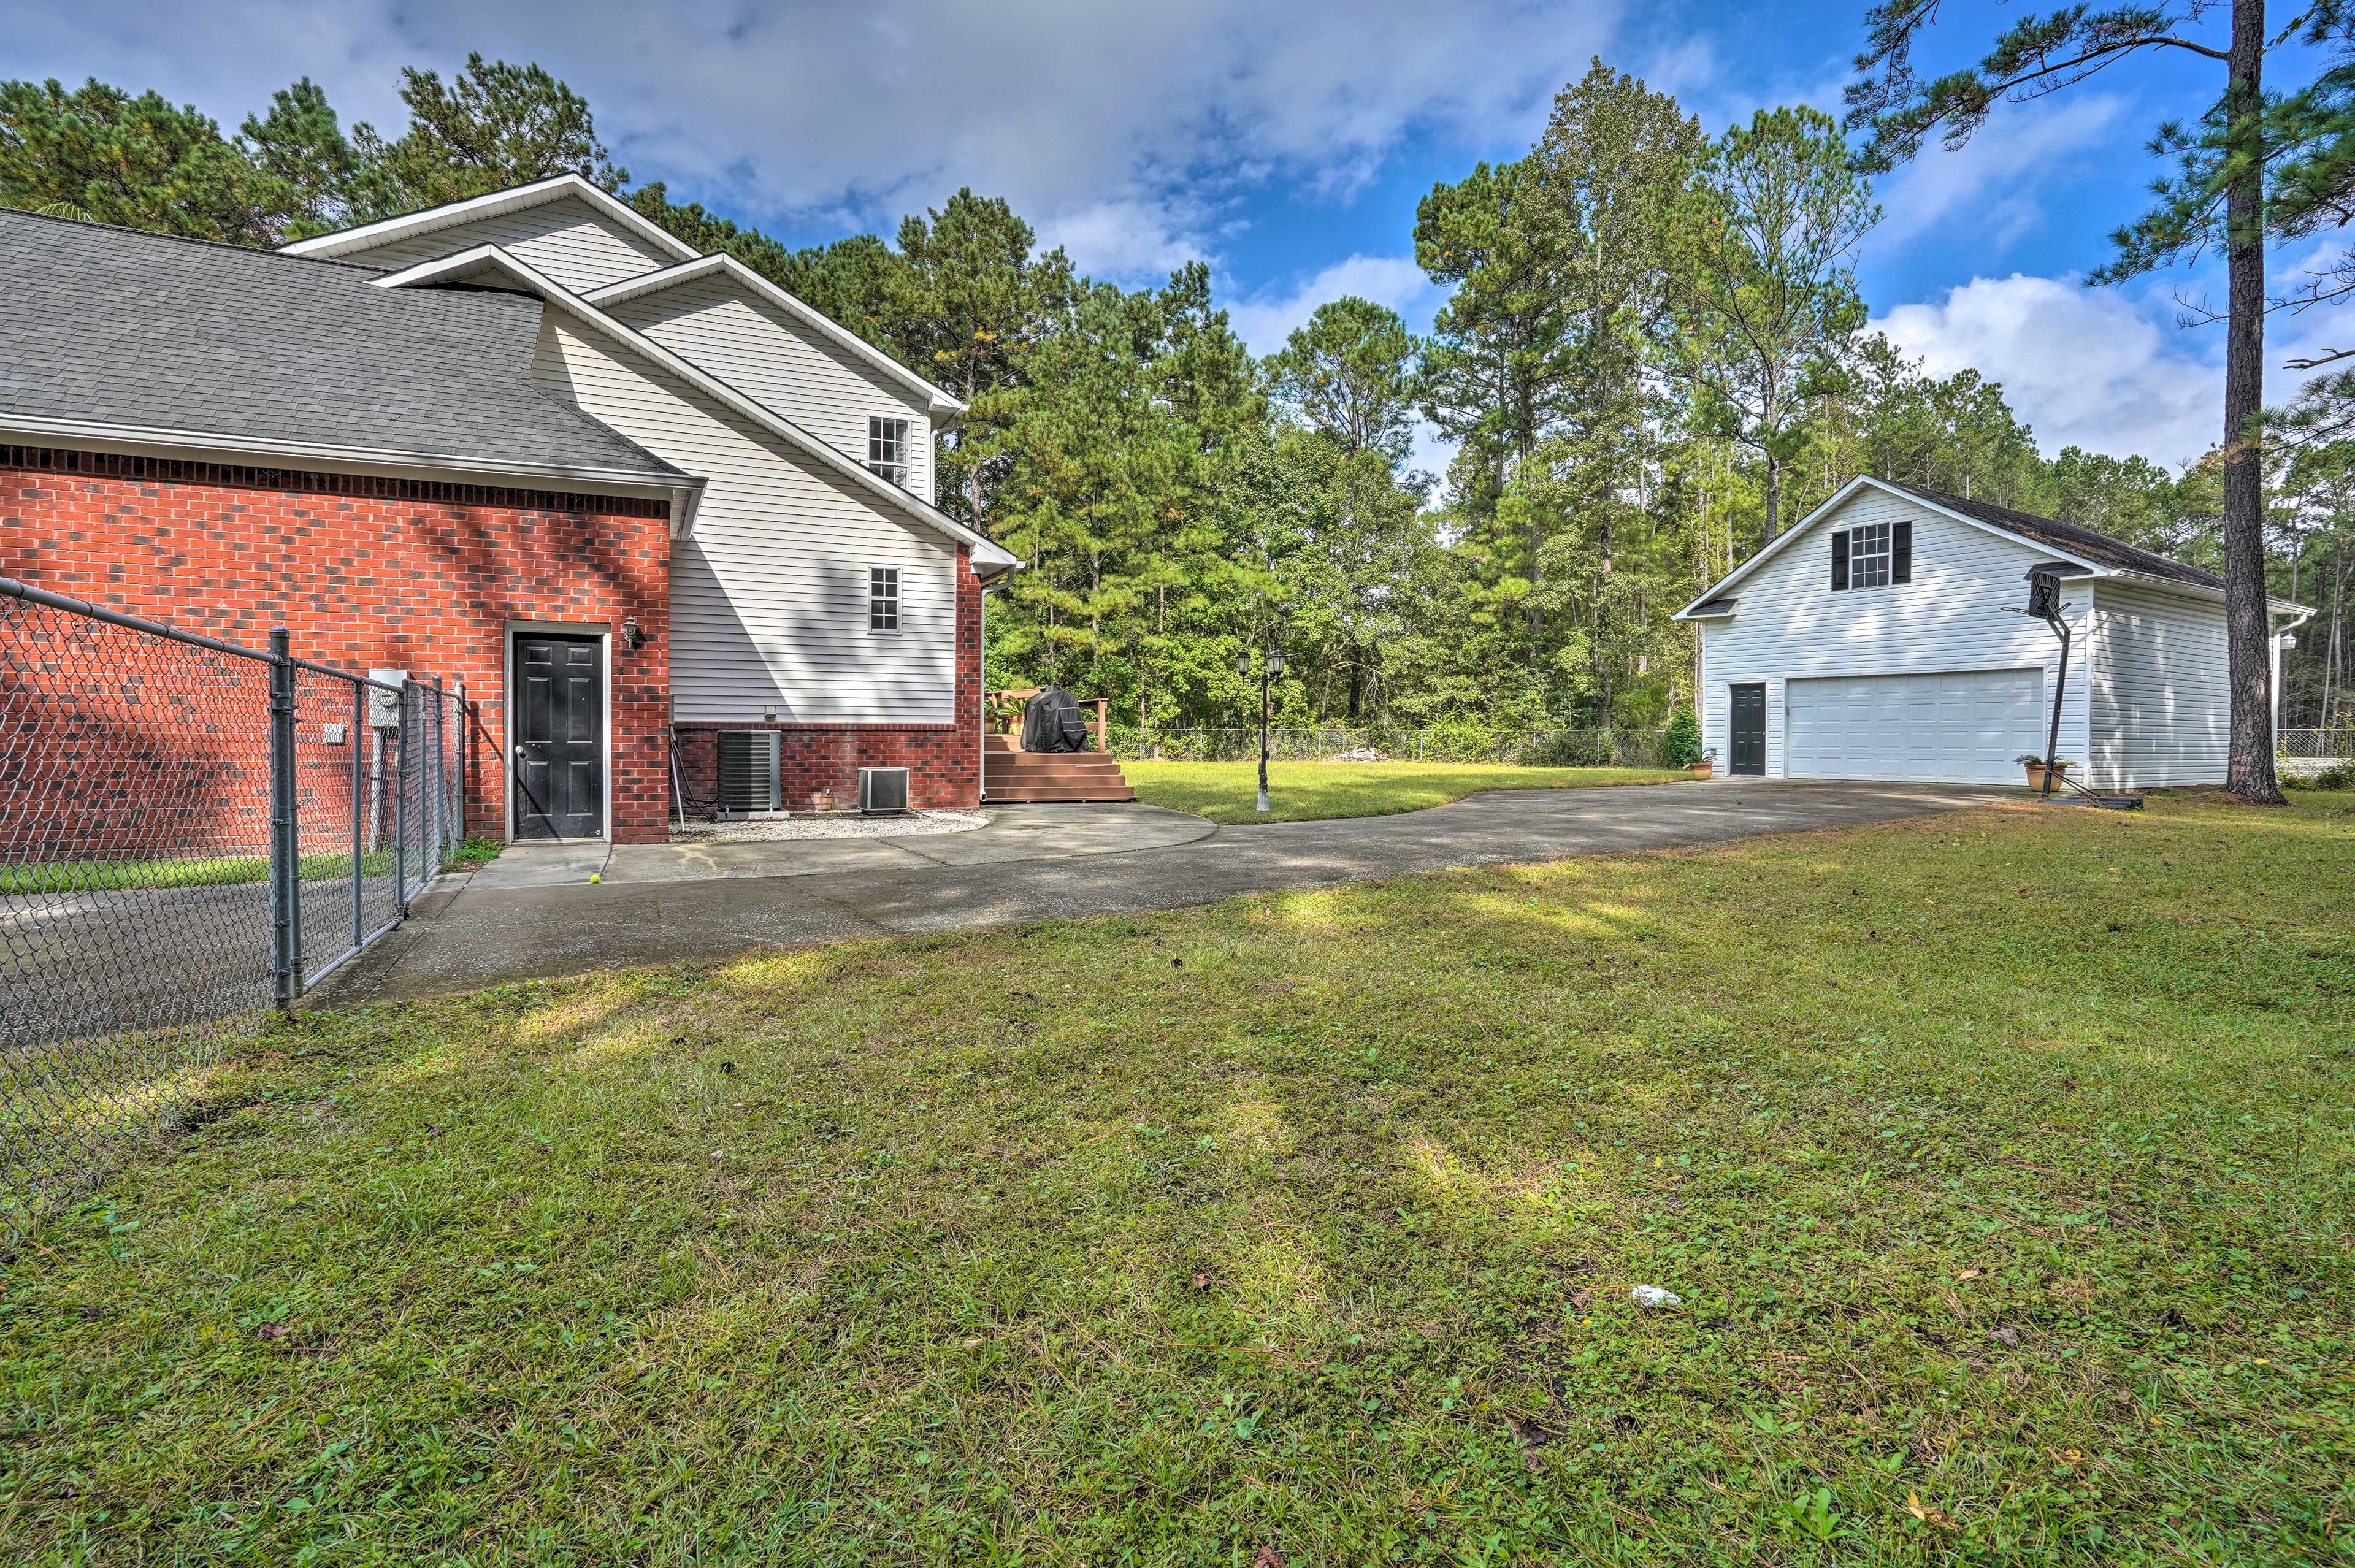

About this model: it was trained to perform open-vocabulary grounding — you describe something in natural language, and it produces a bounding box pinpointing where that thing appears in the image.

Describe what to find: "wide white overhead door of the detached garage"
[1785,668,2049,784]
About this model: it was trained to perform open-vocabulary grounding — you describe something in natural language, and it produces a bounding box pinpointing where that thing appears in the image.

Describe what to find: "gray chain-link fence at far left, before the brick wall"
[0,577,464,1238]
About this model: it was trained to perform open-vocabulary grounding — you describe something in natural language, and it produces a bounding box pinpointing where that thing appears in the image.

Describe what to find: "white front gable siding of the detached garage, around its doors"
[1700,488,2091,777]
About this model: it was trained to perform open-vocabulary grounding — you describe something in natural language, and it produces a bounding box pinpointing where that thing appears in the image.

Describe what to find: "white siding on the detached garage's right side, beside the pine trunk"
[2075,581,2232,789]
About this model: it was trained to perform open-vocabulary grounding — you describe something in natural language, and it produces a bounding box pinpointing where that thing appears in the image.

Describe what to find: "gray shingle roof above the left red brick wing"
[0,210,678,480]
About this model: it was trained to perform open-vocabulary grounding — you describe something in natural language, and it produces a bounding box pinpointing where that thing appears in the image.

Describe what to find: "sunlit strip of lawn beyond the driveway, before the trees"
[1121,760,1688,822]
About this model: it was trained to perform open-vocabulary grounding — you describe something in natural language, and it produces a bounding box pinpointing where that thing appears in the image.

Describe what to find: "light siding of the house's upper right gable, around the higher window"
[605,275,933,502]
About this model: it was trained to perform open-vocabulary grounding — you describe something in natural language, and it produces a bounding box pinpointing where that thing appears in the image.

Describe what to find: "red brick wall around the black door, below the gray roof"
[0,445,671,852]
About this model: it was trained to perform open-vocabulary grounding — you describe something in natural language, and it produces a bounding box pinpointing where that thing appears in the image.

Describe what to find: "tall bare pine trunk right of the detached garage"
[2223,0,2284,805]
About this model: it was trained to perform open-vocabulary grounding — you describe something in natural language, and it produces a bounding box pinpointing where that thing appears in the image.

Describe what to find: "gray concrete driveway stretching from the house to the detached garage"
[320,779,2018,1005]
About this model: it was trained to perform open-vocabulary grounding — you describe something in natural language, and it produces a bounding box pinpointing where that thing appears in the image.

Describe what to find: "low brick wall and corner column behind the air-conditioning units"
[678,544,982,813]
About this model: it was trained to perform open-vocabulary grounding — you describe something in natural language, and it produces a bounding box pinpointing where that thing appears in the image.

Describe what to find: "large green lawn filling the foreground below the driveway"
[0,796,2355,1568]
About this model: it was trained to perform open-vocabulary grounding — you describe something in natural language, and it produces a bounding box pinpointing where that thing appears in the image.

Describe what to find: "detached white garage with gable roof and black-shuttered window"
[1677,478,2308,789]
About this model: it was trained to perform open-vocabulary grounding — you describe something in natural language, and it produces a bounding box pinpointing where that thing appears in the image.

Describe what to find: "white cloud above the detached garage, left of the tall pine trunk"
[1872,273,2223,464]
